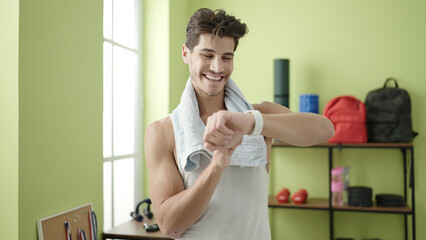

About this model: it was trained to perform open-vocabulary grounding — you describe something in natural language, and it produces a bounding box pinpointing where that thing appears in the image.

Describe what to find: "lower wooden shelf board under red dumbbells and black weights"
[268,196,412,214]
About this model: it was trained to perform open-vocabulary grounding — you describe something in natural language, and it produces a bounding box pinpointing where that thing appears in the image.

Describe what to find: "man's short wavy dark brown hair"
[185,8,248,51]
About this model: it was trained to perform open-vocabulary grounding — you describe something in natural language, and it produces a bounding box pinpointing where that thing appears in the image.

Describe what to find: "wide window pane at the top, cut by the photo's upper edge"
[113,0,137,49]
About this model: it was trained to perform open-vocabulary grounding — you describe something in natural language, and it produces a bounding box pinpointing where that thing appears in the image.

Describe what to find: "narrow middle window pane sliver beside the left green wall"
[103,42,112,157]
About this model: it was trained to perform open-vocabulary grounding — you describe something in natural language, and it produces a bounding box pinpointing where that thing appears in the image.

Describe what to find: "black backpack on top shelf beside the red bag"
[365,78,418,142]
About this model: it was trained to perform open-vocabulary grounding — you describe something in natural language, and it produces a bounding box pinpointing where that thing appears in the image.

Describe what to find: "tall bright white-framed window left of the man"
[103,0,143,230]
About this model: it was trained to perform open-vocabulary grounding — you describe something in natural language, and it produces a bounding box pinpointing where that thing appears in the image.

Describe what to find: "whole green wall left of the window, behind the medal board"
[0,0,103,240]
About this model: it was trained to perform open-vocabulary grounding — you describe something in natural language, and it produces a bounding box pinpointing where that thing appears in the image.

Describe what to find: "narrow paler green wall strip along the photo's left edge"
[0,0,19,239]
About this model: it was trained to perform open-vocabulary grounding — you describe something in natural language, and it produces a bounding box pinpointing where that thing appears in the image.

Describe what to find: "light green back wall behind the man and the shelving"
[144,0,426,240]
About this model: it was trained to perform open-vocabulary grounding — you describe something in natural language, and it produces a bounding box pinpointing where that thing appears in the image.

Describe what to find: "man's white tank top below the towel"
[178,156,271,240]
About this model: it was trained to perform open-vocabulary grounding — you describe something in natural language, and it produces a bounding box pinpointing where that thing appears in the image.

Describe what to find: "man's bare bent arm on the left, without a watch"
[145,118,233,238]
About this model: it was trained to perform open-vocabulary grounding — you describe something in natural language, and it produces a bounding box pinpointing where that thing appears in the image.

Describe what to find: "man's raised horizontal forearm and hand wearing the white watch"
[204,102,334,151]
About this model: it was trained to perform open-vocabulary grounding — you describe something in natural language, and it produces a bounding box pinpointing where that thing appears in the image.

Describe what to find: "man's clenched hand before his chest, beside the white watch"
[203,110,254,167]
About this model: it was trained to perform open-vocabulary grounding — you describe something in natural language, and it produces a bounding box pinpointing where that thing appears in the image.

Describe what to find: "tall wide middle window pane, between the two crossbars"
[113,46,137,156]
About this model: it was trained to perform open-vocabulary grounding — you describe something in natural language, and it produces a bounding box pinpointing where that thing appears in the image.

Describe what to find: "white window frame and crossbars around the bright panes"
[103,0,144,230]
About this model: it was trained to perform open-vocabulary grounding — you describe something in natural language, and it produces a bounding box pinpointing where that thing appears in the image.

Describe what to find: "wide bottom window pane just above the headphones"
[114,158,135,226]
